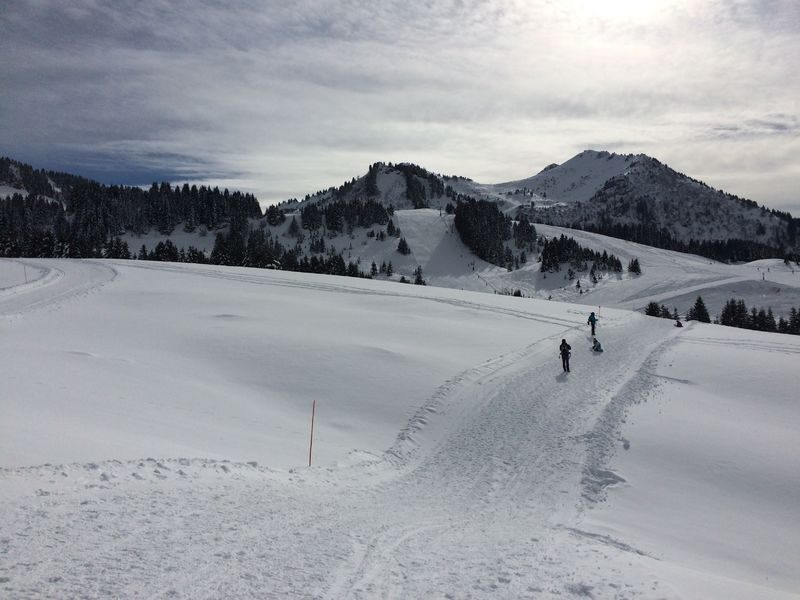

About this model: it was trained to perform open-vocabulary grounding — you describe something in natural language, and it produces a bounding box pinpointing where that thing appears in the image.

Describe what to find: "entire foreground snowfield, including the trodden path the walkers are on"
[0,260,800,598]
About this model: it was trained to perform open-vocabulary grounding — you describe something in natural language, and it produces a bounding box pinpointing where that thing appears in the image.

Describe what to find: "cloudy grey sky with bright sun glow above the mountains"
[0,0,800,216]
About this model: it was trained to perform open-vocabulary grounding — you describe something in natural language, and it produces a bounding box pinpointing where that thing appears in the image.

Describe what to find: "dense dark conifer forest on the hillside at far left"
[0,158,262,258]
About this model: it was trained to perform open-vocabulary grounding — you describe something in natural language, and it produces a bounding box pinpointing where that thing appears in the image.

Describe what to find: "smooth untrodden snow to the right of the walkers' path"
[586,326,800,598]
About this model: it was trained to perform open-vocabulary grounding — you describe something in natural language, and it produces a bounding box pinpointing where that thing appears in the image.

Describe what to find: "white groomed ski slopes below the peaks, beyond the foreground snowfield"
[390,210,800,319]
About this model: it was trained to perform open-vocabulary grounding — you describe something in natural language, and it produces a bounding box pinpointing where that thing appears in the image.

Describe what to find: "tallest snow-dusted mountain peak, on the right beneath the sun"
[450,150,800,254]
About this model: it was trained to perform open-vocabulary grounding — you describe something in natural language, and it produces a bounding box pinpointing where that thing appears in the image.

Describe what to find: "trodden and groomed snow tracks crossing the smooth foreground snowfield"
[0,261,680,598]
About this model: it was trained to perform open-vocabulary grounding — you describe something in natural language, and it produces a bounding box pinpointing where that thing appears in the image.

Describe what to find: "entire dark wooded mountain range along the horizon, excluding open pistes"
[0,150,798,274]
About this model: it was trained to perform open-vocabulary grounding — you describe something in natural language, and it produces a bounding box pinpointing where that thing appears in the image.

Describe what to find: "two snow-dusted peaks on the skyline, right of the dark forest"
[274,150,800,255]
